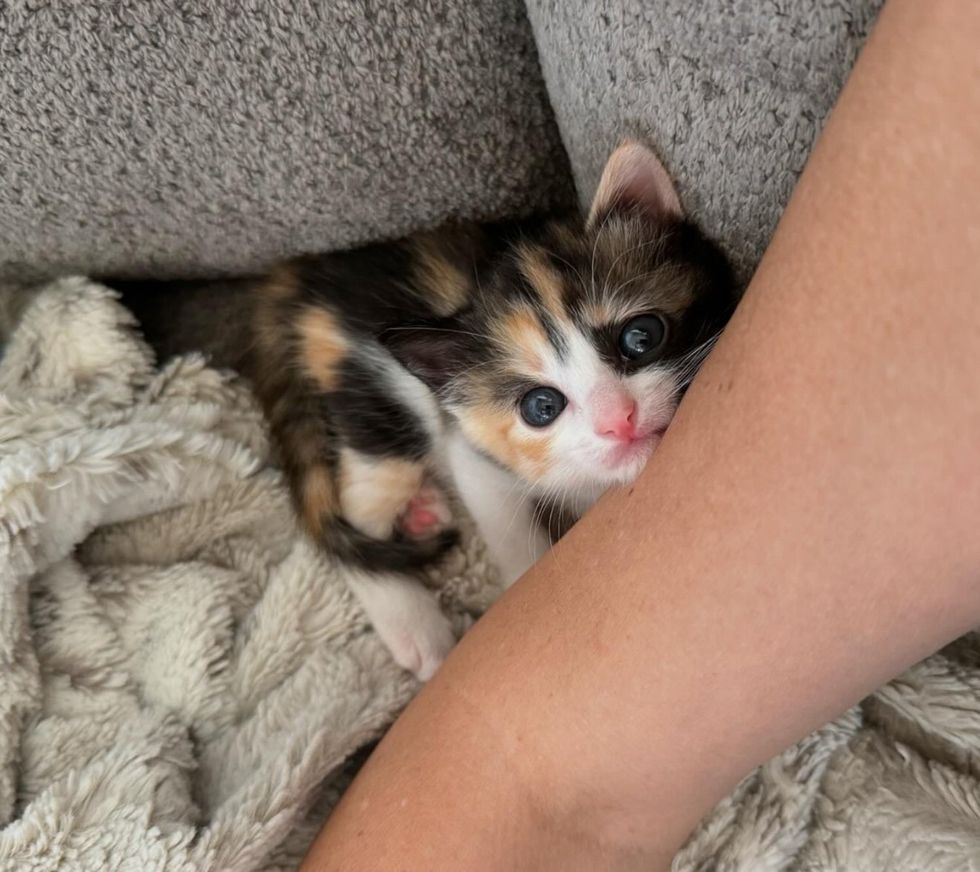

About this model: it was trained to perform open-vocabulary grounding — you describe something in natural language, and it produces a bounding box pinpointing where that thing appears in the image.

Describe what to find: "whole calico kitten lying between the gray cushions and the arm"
[115,142,736,679]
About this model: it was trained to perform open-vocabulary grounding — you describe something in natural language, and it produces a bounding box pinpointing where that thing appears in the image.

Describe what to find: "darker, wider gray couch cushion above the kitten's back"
[0,0,571,276]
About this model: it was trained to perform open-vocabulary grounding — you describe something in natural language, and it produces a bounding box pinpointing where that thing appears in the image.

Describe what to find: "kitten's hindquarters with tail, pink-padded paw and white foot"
[253,304,464,680]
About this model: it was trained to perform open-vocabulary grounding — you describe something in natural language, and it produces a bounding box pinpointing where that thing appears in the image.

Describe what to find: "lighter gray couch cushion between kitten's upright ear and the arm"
[527,0,883,278]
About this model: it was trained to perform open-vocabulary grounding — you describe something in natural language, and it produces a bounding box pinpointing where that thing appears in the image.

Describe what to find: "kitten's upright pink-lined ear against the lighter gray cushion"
[589,140,684,226]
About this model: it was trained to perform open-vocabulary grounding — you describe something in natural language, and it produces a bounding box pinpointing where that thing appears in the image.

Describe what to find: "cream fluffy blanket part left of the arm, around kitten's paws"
[0,279,495,872]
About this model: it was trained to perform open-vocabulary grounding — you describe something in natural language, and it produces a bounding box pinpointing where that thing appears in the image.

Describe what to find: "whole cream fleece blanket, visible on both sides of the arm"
[0,278,980,872]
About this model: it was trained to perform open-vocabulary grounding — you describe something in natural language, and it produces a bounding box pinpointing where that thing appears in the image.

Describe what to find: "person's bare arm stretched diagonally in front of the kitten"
[303,0,980,872]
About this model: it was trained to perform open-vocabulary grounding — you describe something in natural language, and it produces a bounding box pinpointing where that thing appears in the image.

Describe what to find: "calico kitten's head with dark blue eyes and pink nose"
[390,142,735,495]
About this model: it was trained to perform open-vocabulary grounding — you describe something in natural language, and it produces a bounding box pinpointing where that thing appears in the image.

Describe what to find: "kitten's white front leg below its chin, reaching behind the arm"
[446,431,551,587]
